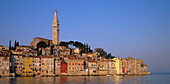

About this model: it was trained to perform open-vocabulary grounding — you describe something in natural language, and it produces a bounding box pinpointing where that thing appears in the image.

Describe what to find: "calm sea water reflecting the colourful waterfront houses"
[0,73,170,84]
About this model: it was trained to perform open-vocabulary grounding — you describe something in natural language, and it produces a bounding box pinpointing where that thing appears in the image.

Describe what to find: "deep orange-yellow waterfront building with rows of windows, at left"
[22,56,33,76]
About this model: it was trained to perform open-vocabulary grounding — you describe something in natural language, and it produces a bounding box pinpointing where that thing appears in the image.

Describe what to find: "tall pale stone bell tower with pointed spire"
[52,9,60,45]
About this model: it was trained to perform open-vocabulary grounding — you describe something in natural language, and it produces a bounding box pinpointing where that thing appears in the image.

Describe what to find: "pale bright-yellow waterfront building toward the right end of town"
[113,57,122,74]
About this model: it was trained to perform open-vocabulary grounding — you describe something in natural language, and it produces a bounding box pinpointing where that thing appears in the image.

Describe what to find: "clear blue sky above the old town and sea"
[0,0,170,72]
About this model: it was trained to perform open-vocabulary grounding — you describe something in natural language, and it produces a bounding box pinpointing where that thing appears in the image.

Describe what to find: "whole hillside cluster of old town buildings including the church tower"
[0,10,150,76]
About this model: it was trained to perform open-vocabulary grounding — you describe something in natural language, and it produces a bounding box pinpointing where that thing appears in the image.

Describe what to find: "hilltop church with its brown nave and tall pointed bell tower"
[30,9,60,49]
